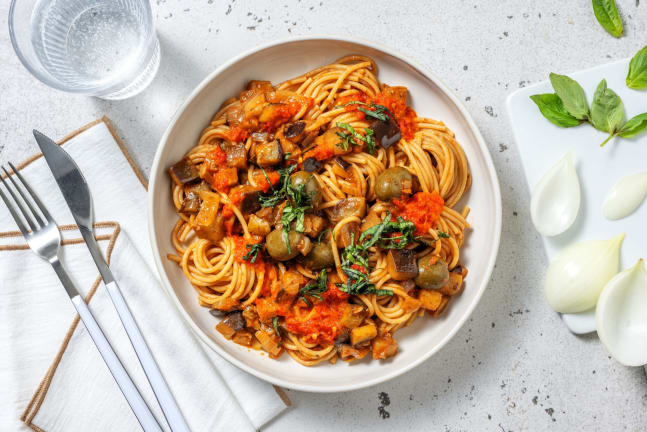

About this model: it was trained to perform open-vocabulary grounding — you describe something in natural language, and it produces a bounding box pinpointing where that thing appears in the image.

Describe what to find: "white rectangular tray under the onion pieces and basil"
[507,59,647,334]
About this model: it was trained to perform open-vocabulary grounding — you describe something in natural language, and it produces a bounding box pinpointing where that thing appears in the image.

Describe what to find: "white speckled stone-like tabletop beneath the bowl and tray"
[0,0,647,432]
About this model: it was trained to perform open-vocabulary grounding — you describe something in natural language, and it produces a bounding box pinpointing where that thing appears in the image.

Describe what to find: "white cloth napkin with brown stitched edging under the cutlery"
[0,121,286,432]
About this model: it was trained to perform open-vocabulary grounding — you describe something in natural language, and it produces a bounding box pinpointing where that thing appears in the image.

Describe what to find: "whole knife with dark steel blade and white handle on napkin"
[33,129,190,432]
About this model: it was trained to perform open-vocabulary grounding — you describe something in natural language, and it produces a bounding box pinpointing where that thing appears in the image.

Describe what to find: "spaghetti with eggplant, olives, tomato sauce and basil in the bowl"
[168,55,471,366]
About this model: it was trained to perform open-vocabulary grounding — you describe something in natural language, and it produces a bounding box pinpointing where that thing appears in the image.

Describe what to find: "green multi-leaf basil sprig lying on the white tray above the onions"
[530,74,647,146]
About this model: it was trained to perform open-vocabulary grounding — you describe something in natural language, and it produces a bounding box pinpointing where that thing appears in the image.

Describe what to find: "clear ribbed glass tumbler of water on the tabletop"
[9,0,160,99]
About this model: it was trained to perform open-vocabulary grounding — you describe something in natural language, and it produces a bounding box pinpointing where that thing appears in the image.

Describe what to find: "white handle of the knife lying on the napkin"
[106,281,190,432]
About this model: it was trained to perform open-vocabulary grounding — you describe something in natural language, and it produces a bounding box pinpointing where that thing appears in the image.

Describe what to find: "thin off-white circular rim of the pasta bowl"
[147,35,503,393]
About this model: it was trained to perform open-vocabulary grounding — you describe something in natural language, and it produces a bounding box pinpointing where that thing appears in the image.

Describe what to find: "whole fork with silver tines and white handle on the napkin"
[0,163,162,432]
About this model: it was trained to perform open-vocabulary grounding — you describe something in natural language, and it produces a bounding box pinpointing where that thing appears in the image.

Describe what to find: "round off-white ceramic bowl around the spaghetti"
[148,37,501,392]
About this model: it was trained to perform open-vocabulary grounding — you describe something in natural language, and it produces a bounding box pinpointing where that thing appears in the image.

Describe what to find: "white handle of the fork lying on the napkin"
[68,296,162,432]
